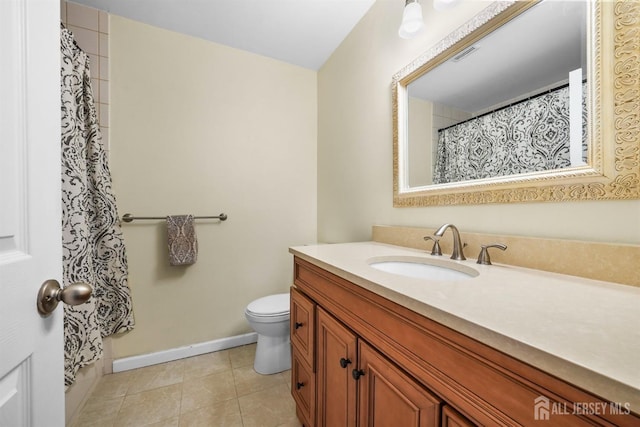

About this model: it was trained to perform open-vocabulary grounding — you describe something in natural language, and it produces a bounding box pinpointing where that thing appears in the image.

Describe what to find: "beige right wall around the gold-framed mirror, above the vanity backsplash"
[318,0,640,246]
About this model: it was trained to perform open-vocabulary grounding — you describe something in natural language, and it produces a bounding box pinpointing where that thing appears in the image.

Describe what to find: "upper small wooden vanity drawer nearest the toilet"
[290,287,316,372]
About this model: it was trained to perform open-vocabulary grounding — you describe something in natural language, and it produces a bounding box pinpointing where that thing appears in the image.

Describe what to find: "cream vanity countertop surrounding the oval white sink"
[289,242,640,413]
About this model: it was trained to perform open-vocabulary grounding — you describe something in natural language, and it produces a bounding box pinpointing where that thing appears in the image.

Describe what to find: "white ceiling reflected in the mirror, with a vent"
[409,1,587,115]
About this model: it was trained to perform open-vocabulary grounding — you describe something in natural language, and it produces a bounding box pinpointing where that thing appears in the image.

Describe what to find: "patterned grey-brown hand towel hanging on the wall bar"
[167,215,198,265]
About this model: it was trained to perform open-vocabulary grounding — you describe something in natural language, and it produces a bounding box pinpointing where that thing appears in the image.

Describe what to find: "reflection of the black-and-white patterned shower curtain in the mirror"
[433,83,587,184]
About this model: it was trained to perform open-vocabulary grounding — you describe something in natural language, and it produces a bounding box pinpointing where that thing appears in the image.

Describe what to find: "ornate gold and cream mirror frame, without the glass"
[392,0,640,207]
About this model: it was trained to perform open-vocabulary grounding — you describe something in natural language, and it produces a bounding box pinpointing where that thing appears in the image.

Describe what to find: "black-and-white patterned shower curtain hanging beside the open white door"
[61,27,134,386]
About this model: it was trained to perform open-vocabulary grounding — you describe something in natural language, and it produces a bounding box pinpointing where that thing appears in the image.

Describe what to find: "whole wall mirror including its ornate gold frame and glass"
[393,1,640,207]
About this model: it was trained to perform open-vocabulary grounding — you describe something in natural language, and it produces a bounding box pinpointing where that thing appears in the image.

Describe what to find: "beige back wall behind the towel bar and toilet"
[110,16,317,358]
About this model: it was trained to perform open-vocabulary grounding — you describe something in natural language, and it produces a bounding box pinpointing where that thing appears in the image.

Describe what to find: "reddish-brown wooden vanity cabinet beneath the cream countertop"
[291,256,640,427]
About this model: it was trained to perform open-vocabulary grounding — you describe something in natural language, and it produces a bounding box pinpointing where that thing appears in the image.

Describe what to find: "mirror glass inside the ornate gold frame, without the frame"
[405,1,588,187]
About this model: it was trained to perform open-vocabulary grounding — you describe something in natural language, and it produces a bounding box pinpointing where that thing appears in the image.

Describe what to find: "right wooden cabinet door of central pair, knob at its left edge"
[358,340,441,427]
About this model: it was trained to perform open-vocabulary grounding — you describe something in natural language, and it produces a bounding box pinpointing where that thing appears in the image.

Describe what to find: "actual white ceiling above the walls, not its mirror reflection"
[73,0,376,70]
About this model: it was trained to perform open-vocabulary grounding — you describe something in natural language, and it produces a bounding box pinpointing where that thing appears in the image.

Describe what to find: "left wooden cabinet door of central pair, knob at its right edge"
[316,307,357,427]
